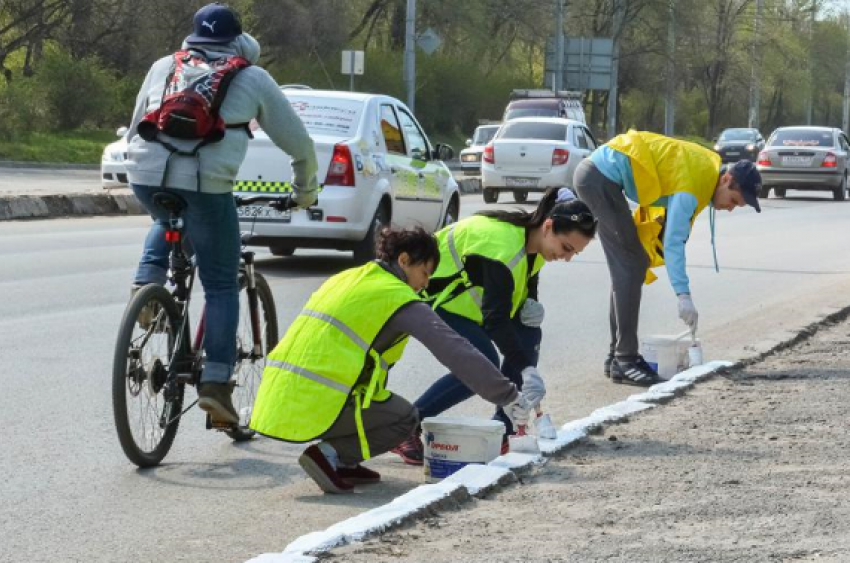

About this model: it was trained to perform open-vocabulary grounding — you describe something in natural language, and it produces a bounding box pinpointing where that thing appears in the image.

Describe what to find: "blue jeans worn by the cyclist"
[131,185,242,383]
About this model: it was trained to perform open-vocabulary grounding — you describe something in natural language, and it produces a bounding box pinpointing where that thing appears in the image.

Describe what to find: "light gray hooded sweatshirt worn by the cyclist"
[126,33,318,198]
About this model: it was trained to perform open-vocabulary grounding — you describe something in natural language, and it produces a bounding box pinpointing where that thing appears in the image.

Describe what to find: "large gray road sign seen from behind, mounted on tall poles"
[546,37,614,90]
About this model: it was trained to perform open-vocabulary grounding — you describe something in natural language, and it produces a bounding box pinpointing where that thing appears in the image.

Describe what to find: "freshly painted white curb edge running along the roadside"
[247,361,733,563]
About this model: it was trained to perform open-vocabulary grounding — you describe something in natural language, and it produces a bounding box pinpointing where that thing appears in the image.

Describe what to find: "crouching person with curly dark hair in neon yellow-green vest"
[251,228,540,493]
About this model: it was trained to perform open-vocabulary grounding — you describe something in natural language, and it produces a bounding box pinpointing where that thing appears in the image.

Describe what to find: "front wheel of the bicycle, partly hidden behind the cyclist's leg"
[227,272,278,442]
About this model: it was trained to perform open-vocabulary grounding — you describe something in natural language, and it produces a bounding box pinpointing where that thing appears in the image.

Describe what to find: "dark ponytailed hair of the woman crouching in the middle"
[476,188,596,238]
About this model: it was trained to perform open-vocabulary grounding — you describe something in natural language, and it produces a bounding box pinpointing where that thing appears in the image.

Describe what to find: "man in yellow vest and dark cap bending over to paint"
[574,131,761,386]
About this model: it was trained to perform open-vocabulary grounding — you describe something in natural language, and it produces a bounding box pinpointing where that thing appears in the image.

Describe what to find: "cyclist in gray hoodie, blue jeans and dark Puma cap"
[121,4,318,424]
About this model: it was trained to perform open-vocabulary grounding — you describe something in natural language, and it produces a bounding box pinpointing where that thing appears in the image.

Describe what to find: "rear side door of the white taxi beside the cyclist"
[378,100,419,225]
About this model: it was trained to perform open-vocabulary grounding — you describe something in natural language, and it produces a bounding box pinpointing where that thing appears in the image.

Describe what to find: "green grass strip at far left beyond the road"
[0,130,118,164]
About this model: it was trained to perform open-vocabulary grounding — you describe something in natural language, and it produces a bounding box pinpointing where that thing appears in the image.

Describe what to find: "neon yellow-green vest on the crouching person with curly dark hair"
[251,262,420,459]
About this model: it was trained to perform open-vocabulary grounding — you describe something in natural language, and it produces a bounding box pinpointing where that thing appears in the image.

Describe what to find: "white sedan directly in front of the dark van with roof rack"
[481,117,596,203]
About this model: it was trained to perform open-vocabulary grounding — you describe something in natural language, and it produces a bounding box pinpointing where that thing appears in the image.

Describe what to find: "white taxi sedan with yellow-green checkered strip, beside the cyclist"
[234,88,460,262]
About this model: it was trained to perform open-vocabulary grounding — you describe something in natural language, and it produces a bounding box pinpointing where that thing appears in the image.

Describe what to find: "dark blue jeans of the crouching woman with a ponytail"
[414,309,543,434]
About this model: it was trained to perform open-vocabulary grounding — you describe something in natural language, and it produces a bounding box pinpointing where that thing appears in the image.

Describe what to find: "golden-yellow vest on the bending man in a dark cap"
[606,130,721,284]
